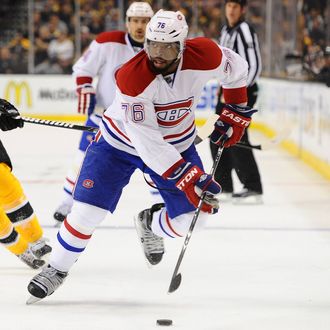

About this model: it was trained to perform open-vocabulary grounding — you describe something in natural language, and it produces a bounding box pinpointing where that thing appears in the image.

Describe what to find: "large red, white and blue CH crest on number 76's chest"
[155,97,194,127]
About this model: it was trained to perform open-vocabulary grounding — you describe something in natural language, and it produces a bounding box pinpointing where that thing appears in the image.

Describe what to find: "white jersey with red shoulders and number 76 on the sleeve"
[100,37,248,175]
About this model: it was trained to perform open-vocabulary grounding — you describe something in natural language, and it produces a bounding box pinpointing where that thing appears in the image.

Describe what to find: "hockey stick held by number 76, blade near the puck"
[168,141,225,293]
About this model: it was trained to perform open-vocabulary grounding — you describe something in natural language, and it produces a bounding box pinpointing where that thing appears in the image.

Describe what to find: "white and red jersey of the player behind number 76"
[73,31,140,109]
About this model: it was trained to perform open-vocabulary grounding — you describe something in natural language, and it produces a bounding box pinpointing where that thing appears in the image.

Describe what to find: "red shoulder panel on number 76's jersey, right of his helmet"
[182,37,222,70]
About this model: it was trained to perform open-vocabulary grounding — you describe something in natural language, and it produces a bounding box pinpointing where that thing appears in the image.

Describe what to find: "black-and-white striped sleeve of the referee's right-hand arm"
[236,22,262,86]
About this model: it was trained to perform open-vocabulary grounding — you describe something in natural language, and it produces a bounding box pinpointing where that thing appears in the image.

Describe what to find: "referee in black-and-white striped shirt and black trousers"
[210,0,262,204]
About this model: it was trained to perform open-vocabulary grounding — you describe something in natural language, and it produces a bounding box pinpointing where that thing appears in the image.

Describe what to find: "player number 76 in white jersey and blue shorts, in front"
[28,10,256,303]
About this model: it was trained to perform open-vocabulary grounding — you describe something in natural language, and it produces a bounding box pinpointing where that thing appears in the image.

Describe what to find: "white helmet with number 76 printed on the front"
[146,9,188,58]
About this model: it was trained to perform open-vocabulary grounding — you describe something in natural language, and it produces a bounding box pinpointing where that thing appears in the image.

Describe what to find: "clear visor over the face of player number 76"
[147,40,180,61]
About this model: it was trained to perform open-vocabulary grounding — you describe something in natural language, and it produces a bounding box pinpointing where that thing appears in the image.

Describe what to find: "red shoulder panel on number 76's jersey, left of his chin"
[116,50,156,96]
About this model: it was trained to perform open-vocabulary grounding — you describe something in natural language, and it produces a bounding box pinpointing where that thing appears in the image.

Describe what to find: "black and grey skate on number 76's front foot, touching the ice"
[26,265,68,305]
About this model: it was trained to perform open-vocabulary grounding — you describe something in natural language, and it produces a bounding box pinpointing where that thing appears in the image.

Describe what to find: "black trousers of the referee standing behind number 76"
[210,84,262,193]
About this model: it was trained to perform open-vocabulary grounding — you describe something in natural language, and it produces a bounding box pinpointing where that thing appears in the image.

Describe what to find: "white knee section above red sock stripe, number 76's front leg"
[67,201,108,235]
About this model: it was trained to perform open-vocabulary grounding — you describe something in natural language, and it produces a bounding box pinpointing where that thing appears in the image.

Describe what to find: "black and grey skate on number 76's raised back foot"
[134,203,165,265]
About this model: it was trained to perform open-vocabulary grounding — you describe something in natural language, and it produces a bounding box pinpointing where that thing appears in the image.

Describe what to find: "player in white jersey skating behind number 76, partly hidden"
[54,2,154,223]
